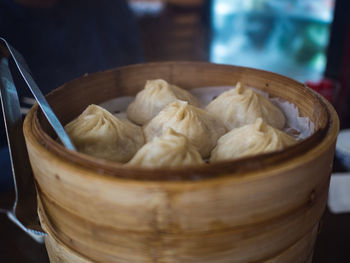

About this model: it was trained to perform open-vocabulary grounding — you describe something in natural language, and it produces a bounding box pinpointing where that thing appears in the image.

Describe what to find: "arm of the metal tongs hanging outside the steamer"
[0,56,46,243]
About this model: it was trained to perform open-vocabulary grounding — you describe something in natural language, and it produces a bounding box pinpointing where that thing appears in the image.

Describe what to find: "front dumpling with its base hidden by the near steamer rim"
[127,128,204,167]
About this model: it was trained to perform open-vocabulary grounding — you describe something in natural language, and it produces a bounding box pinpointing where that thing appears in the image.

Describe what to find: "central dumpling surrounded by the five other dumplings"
[143,100,226,158]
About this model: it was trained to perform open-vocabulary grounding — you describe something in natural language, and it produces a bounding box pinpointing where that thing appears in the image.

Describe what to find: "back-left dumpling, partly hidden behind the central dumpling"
[127,79,199,125]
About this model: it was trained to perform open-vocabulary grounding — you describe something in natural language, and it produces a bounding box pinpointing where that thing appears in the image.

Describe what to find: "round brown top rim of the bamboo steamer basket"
[24,62,339,181]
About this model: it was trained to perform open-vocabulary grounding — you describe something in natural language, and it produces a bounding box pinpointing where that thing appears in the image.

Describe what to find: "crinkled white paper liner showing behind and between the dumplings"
[100,86,314,140]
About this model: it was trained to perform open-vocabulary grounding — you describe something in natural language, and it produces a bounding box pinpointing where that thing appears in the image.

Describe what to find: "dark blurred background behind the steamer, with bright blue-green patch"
[0,0,350,263]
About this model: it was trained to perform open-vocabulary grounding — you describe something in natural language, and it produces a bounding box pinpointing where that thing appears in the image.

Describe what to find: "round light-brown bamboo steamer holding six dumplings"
[24,62,339,263]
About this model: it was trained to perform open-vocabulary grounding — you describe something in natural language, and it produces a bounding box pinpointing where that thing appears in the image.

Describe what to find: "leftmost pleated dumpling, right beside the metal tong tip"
[65,105,144,162]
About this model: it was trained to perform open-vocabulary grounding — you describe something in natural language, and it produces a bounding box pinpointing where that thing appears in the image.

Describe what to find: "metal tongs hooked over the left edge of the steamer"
[0,38,75,243]
